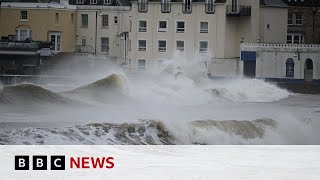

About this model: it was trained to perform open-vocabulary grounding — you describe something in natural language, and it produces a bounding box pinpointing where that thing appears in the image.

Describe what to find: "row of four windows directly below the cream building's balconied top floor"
[138,20,209,33]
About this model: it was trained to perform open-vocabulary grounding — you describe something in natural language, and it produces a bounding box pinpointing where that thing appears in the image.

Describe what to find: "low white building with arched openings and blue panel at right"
[241,43,320,83]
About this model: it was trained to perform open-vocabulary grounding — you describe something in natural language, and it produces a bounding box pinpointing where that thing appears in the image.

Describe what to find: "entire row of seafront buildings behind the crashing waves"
[0,0,320,81]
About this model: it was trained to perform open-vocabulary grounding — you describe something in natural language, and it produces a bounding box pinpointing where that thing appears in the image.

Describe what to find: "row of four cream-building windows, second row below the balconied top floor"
[138,40,208,53]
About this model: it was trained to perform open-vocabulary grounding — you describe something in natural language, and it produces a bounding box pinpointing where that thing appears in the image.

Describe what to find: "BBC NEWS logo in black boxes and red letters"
[14,155,114,170]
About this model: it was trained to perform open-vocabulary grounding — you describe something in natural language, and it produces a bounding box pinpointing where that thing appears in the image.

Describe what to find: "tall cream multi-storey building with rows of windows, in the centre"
[128,0,288,71]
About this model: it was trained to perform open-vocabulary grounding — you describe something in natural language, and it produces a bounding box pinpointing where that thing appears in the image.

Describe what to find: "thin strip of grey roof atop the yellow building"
[1,2,76,9]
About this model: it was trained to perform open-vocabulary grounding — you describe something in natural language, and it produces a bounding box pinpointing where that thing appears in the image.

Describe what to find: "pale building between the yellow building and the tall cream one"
[69,0,131,64]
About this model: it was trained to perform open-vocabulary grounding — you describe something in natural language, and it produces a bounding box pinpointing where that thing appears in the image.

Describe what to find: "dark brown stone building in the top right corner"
[283,0,320,44]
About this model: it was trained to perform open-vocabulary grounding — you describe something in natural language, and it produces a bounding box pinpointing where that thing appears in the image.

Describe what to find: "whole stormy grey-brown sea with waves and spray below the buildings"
[0,56,320,145]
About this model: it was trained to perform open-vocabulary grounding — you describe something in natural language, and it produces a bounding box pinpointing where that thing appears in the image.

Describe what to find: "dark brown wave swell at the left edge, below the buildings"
[0,84,70,105]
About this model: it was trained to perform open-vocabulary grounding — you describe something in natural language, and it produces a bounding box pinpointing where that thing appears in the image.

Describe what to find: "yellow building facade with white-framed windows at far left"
[0,2,76,53]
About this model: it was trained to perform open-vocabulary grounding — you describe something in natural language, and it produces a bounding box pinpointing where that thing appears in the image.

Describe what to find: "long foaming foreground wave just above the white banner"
[0,119,277,145]
